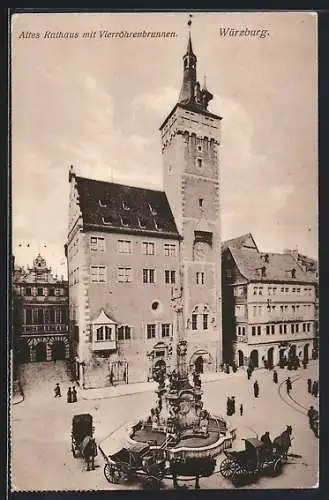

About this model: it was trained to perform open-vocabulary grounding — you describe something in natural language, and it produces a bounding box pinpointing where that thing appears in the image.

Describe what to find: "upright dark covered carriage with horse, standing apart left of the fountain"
[71,413,97,470]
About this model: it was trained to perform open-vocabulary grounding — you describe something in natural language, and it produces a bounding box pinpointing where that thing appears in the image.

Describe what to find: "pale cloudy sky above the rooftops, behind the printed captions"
[11,12,318,276]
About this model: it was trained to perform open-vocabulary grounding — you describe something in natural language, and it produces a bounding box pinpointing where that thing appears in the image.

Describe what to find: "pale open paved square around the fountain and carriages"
[11,362,318,491]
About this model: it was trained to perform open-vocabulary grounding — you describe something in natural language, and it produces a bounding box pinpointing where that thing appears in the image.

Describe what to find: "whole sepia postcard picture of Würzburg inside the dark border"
[8,11,320,494]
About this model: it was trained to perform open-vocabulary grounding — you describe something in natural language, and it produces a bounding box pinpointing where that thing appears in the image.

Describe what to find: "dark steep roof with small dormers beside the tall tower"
[76,176,179,238]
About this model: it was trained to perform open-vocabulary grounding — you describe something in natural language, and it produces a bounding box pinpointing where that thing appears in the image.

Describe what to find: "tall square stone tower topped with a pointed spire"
[160,21,222,372]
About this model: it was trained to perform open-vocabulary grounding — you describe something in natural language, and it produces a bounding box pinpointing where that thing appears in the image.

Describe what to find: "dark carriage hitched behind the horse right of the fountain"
[219,438,284,486]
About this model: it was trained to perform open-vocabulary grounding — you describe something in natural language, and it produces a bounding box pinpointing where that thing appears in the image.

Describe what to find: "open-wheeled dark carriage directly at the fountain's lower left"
[99,443,166,489]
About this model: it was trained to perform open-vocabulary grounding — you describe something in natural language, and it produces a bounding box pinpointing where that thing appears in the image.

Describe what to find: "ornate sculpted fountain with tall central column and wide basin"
[127,289,235,476]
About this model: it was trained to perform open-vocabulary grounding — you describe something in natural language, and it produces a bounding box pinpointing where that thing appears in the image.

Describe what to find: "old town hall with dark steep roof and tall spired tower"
[66,27,222,388]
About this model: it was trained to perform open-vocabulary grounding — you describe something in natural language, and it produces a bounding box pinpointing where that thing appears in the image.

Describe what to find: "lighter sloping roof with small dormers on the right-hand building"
[223,233,313,283]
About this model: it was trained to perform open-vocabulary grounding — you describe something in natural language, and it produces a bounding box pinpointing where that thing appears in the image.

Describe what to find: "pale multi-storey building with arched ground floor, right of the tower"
[222,233,315,366]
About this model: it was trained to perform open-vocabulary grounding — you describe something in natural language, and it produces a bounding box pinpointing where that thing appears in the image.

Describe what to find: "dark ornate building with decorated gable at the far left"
[12,254,70,363]
